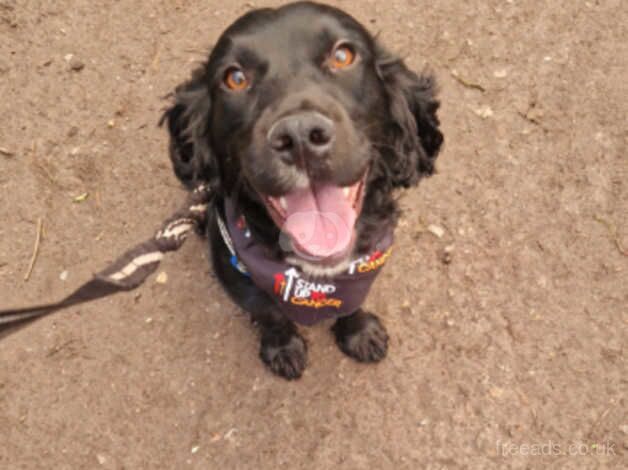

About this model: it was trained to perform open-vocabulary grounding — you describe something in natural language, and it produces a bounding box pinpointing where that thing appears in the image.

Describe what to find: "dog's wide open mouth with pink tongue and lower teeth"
[263,173,366,264]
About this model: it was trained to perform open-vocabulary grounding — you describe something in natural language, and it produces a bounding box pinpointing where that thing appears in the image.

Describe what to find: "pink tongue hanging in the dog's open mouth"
[283,184,356,258]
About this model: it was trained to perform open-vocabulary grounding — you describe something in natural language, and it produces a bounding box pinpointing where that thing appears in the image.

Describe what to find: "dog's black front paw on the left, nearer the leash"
[260,329,307,380]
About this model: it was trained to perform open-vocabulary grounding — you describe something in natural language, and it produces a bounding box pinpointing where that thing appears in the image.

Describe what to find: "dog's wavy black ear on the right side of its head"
[377,50,443,187]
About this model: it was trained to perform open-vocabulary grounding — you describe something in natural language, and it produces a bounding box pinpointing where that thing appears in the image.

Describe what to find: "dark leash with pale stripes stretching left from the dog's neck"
[0,184,213,336]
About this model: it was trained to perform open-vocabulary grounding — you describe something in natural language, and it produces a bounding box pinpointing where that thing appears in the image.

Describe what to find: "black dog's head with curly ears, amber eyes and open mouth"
[165,2,443,272]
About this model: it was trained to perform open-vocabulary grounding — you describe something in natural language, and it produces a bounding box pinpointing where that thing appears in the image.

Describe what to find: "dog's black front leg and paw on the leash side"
[209,211,307,380]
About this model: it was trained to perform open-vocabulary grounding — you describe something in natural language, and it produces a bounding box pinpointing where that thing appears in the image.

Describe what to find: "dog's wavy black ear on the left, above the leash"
[159,65,219,189]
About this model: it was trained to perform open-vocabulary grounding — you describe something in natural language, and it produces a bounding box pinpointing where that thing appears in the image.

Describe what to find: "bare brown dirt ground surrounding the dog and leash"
[0,0,628,469]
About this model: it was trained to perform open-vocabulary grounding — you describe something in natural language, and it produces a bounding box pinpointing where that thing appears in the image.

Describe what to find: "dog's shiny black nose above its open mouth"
[267,112,336,164]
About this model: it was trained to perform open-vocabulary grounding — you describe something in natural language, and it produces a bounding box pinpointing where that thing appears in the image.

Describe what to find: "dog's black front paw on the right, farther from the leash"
[332,310,388,362]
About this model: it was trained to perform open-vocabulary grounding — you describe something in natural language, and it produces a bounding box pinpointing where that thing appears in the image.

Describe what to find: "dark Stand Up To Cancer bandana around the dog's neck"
[217,199,393,325]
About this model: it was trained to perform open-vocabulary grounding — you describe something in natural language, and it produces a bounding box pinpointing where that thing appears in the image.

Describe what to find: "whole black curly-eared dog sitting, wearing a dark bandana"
[164,2,443,379]
